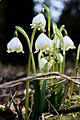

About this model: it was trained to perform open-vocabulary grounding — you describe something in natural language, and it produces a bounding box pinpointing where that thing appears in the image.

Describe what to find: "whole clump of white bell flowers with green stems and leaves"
[7,5,79,120]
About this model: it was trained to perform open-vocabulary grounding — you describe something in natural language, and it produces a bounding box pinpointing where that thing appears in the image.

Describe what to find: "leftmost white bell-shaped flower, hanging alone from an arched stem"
[7,37,24,53]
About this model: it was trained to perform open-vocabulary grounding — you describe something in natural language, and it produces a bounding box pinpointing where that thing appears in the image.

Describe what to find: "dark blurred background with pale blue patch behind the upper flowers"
[0,0,80,66]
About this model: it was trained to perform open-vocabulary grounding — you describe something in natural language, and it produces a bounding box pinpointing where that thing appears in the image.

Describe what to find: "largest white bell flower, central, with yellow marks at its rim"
[35,33,53,52]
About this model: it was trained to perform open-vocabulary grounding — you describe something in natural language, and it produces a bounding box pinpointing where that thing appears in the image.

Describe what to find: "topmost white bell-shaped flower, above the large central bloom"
[30,13,46,30]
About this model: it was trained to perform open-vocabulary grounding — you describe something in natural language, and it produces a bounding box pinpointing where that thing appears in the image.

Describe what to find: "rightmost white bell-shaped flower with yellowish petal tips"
[64,36,75,50]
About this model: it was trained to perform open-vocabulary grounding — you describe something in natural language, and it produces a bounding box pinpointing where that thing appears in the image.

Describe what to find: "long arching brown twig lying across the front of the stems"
[0,72,80,88]
